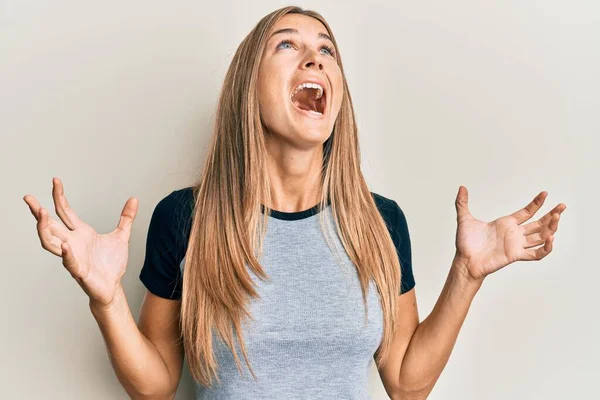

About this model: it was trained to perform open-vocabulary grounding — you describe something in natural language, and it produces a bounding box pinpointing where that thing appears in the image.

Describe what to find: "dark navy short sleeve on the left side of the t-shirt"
[139,189,192,300]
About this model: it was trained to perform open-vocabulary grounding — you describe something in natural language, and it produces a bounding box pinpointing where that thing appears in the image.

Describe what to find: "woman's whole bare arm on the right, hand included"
[379,186,566,400]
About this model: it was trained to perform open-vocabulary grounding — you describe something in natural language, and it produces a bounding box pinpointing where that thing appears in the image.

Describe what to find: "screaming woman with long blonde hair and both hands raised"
[24,7,566,399]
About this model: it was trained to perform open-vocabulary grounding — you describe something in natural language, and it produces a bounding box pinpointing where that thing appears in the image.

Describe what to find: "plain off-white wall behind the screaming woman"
[0,0,600,400]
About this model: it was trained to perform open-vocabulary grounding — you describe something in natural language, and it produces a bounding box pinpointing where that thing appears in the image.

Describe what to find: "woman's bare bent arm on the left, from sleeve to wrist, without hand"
[90,287,184,399]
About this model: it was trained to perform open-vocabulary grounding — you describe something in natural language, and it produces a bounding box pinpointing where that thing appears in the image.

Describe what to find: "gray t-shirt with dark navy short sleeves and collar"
[140,188,415,400]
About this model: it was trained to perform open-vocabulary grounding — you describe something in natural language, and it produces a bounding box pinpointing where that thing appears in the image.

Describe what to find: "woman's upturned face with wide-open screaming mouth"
[258,14,344,147]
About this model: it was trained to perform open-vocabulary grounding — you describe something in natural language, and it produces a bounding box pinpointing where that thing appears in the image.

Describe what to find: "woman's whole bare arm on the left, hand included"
[23,178,183,399]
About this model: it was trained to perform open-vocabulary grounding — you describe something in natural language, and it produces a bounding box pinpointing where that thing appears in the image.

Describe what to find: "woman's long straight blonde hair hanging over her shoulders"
[180,6,400,386]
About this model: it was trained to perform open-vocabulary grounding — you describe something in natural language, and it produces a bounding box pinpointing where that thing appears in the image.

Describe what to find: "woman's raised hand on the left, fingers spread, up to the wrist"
[23,178,138,306]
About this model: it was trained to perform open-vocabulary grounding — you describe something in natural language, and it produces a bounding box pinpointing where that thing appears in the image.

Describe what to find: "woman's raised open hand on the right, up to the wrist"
[455,186,567,279]
